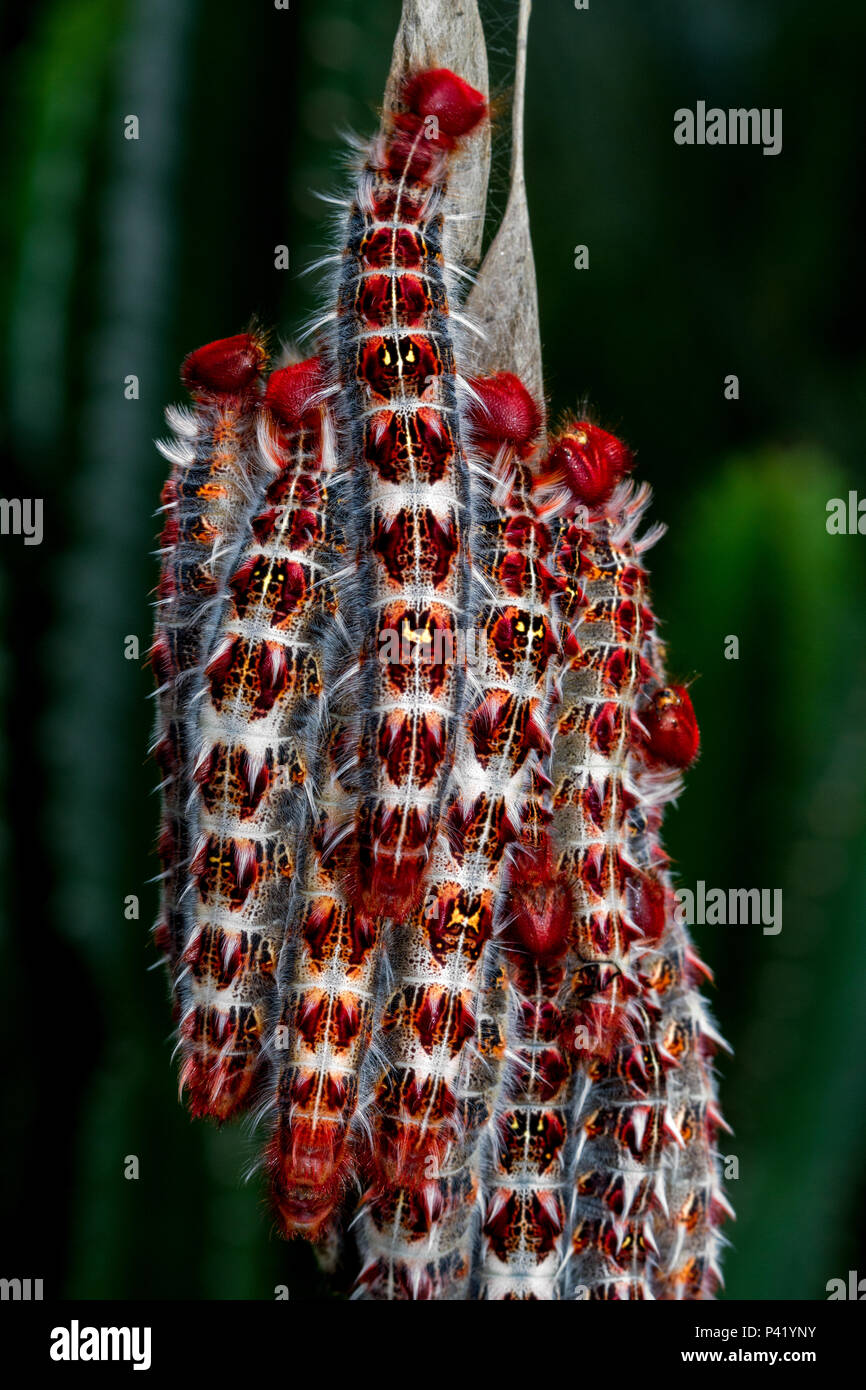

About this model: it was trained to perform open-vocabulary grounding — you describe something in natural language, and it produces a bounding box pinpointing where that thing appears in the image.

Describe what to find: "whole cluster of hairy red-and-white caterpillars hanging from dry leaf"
[152,68,730,1301]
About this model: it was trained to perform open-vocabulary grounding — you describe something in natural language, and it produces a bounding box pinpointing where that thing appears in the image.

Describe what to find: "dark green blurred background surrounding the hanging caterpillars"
[0,0,866,1298]
